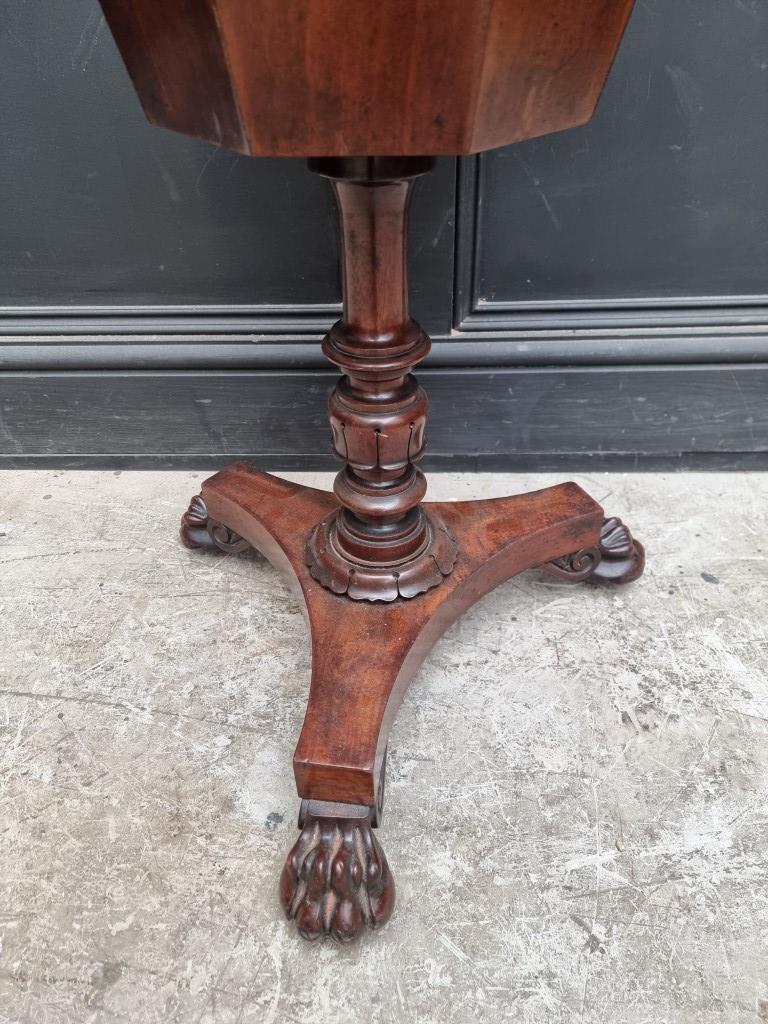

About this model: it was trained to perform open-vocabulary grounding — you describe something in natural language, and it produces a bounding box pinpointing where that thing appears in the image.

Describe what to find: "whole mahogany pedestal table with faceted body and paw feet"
[101,0,644,941]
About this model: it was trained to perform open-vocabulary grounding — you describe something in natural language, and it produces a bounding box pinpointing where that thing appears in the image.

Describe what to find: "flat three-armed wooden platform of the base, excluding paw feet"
[203,463,604,806]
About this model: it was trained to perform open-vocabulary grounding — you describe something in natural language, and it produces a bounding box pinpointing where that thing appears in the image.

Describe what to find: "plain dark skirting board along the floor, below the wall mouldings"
[0,364,768,471]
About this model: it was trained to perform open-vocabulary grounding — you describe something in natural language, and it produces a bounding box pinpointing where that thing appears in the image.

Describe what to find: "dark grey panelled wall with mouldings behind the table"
[0,0,768,467]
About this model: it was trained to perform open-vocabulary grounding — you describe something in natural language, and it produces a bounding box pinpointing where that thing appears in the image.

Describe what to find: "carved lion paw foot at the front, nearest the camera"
[280,801,394,942]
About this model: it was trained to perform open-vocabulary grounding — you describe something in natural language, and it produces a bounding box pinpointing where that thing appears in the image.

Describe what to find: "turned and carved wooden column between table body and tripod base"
[308,157,453,600]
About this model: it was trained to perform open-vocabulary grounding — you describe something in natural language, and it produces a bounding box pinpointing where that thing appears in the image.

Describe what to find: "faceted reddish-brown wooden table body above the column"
[101,0,634,157]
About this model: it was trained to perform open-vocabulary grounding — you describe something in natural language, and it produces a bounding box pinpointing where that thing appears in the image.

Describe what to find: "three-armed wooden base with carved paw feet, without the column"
[181,463,644,941]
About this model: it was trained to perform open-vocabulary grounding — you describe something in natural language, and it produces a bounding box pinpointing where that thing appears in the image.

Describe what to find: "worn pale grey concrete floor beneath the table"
[0,472,768,1024]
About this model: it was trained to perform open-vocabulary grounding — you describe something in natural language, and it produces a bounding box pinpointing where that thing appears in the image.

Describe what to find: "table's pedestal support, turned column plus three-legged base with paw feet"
[174,157,644,941]
